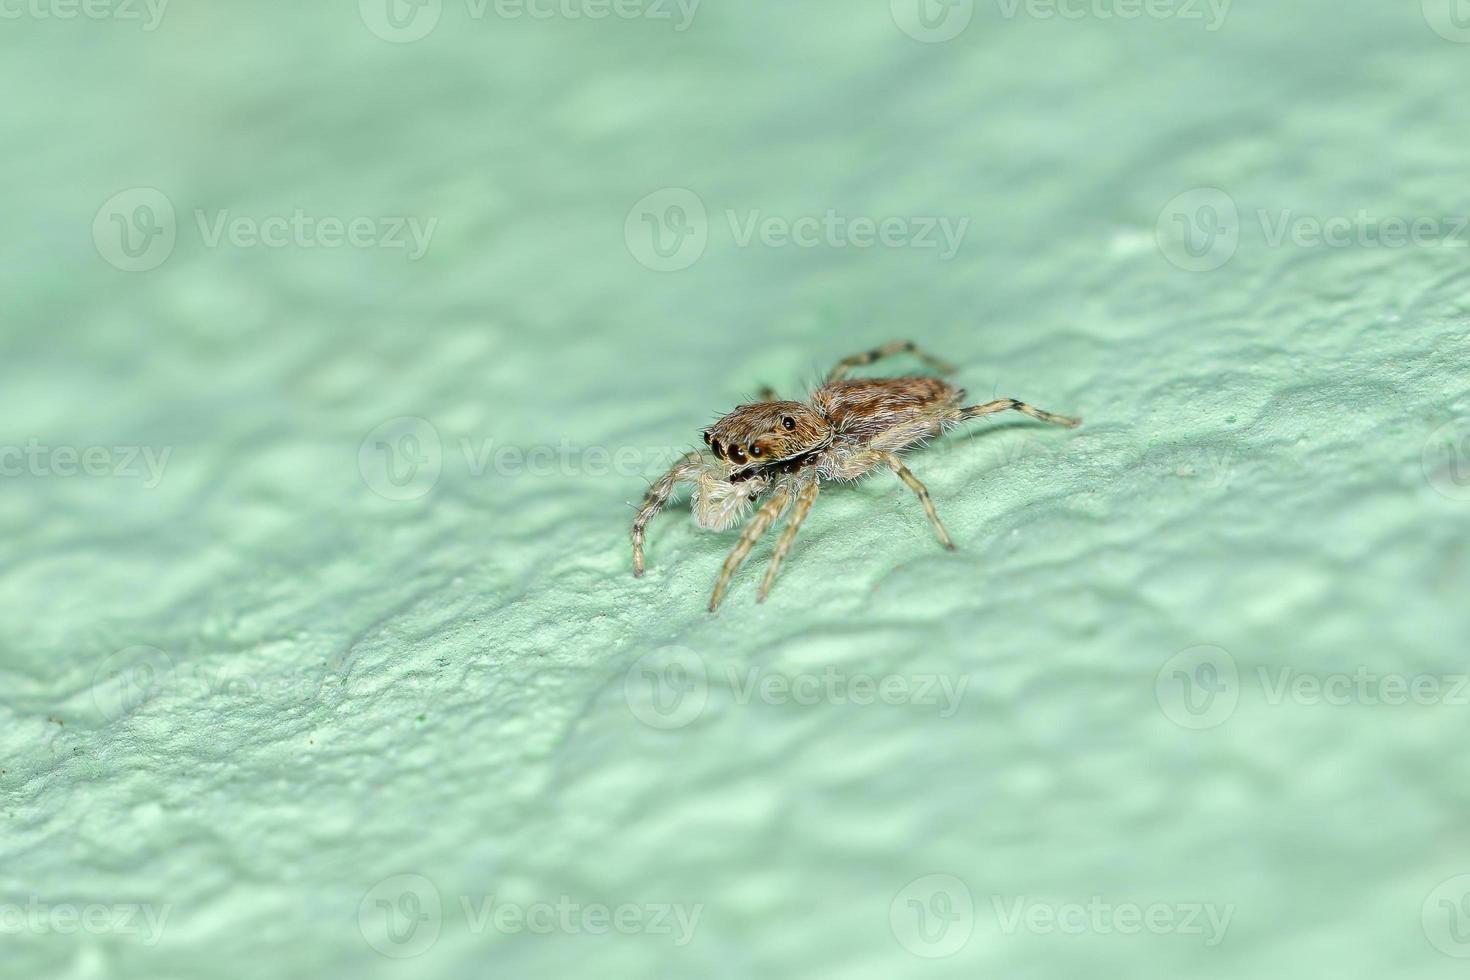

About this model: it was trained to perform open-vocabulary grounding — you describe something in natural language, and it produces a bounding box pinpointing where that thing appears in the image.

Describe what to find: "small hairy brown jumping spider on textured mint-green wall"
[634,341,1082,613]
